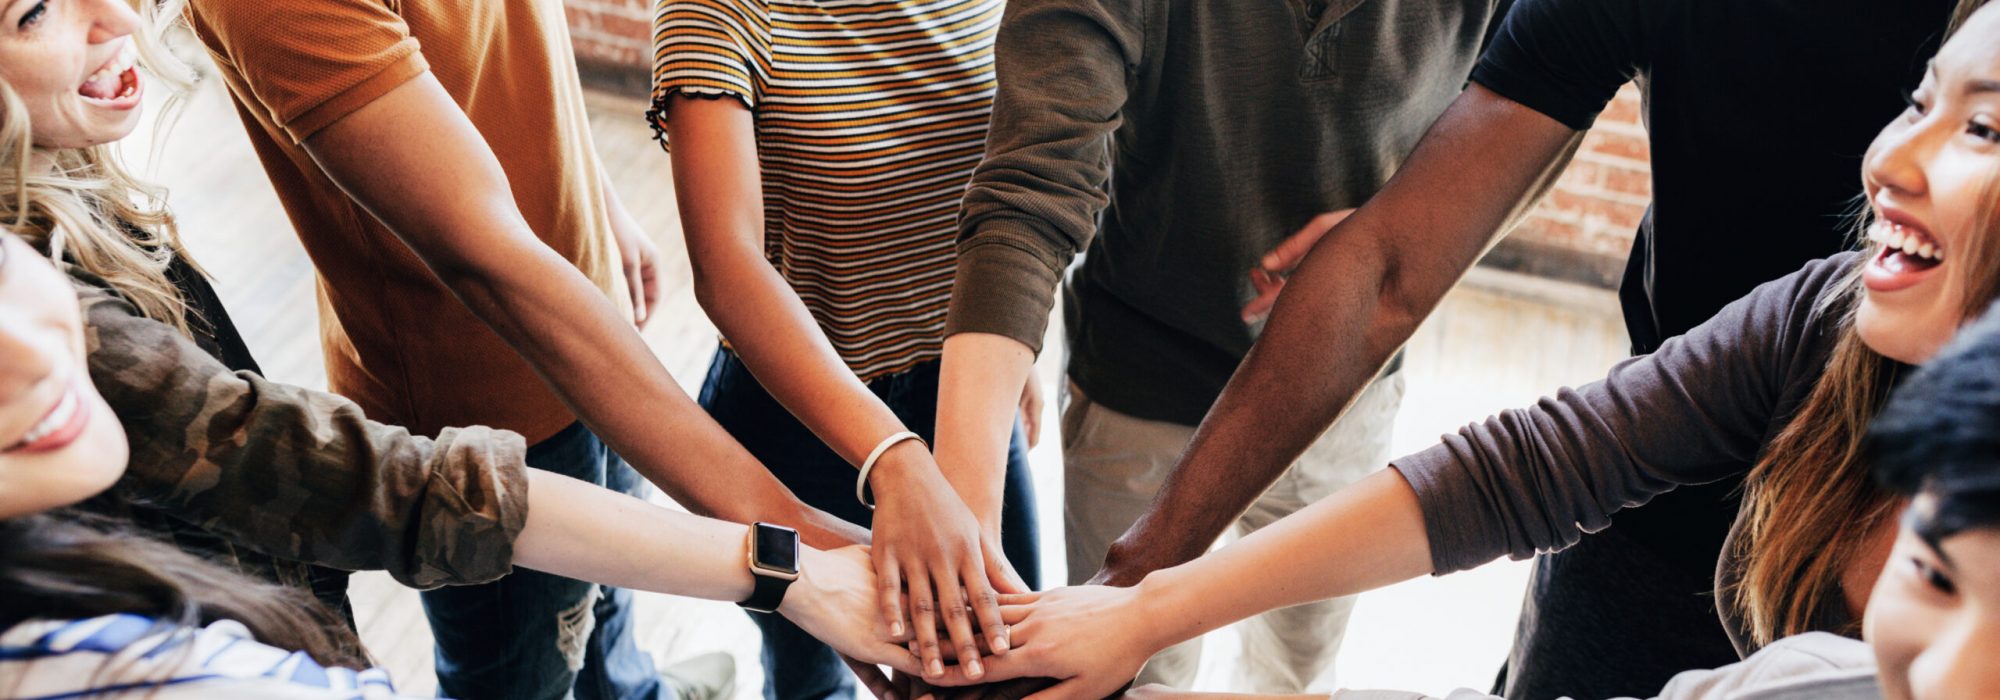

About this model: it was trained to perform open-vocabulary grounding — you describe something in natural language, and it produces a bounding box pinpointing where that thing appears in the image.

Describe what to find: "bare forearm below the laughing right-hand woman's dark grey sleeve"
[1138,470,1430,648]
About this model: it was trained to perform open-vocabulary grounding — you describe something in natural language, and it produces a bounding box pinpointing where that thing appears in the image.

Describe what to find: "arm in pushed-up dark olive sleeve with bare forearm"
[936,0,1148,532]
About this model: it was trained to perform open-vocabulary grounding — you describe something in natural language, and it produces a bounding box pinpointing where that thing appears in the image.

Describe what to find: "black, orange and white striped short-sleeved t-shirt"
[648,0,1004,380]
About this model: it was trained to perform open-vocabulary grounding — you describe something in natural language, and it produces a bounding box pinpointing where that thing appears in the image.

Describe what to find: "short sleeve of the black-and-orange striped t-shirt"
[652,0,770,110]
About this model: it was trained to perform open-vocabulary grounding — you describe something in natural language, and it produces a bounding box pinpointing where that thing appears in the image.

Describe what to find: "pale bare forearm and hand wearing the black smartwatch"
[514,470,918,672]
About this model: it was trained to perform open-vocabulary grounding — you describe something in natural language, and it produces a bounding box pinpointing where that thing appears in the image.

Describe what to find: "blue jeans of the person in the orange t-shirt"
[424,424,672,700]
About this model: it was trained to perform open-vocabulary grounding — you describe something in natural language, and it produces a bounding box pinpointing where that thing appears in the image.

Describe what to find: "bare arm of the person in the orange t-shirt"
[304,72,866,548]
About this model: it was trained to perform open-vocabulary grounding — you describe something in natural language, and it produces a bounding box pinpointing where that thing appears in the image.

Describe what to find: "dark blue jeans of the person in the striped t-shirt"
[702,350,1042,700]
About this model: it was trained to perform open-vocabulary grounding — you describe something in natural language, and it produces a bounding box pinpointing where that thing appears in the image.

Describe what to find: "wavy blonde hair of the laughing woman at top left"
[0,0,192,332]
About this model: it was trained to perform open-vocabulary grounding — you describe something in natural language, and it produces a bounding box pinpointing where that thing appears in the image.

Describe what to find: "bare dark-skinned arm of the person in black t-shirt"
[1092,84,1580,586]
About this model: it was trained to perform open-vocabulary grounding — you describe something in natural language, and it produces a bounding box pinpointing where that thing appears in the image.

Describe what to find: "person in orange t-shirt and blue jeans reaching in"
[186,0,866,698]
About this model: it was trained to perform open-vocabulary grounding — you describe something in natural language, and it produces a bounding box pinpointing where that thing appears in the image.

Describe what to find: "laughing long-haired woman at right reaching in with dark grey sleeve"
[944,4,2000,698]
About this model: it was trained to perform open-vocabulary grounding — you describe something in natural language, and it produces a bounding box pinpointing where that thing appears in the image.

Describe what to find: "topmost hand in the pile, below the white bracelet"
[868,440,1018,680]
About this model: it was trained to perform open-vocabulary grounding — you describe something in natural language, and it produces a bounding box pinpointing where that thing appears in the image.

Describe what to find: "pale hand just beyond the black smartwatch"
[778,546,918,680]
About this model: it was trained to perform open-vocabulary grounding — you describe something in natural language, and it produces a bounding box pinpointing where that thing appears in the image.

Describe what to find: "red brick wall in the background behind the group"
[564,0,1652,286]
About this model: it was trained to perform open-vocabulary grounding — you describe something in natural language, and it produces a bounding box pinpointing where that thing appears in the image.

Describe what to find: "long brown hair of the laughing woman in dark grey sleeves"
[1728,153,2000,646]
